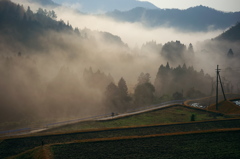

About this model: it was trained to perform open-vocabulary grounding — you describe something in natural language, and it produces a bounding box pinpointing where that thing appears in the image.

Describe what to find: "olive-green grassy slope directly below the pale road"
[40,106,224,133]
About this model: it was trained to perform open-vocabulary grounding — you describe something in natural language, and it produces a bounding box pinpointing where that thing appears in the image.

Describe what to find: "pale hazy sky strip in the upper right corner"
[140,0,240,12]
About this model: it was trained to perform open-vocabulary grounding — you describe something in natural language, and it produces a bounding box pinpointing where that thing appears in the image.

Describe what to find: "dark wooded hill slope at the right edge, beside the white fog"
[215,22,240,41]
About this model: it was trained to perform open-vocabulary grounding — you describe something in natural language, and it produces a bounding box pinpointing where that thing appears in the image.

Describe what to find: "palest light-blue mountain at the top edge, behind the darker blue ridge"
[54,0,157,13]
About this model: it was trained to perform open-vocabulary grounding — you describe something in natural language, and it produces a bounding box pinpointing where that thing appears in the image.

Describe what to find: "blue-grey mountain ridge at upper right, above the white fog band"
[106,6,240,31]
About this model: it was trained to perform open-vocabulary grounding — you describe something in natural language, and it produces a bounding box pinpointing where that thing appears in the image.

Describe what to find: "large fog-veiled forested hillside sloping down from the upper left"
[0,0,128,128]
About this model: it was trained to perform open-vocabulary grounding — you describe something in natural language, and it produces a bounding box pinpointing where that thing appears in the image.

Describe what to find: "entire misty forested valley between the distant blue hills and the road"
[0,0,240,129]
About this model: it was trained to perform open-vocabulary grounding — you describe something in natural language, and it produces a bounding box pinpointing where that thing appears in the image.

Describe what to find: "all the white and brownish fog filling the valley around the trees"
[0,1,240,128]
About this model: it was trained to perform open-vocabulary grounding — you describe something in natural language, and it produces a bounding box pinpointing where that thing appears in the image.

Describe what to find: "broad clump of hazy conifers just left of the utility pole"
[154,63,212,97]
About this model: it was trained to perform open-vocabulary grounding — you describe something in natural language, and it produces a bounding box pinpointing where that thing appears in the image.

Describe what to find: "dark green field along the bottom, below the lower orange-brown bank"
[52,130,240,159]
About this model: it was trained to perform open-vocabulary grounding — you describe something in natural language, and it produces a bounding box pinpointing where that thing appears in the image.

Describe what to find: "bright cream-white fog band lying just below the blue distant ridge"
[56,5,222,48]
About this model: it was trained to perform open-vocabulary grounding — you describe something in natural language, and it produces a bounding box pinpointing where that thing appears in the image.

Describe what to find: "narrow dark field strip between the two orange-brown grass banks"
[0,119,240,158]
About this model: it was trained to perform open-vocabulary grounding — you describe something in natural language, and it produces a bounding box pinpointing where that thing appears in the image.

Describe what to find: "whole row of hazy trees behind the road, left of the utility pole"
[84,62,213,113]
